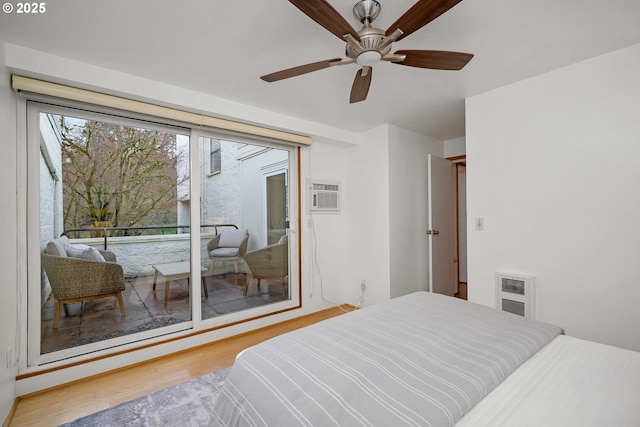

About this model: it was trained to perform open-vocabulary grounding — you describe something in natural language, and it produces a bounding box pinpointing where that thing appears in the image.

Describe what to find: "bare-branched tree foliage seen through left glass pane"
[60,117,184,236]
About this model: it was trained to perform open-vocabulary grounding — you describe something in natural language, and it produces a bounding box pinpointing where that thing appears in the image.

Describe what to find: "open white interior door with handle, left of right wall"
[427,154,457,296]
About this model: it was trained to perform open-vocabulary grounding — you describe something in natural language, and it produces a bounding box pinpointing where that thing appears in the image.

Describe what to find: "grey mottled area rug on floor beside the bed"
[61,368,230,427]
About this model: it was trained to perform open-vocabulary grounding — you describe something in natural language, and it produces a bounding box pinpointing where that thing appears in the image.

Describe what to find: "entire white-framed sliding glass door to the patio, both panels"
[26,101,299,366]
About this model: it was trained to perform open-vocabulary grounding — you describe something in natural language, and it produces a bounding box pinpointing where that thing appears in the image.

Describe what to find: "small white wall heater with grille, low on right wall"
[496,272,536,319]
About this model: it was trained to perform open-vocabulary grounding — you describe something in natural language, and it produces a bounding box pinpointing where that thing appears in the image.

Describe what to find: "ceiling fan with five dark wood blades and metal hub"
[260,0,473,103]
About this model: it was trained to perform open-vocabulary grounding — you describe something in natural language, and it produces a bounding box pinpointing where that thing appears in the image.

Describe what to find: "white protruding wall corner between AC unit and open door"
[346,125,444,305]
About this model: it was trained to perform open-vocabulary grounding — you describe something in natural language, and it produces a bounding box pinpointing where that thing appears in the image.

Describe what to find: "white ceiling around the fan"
[0,0,640,139]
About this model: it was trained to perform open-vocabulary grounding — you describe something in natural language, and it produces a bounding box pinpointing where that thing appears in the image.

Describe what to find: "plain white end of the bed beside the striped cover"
[456,335,640,427]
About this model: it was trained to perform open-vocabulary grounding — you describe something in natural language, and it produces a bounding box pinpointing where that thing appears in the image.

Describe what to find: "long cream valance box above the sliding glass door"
[11,75,311,145]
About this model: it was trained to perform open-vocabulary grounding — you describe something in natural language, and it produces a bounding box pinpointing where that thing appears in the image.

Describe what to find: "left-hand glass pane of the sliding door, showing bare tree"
[36,107,191,360]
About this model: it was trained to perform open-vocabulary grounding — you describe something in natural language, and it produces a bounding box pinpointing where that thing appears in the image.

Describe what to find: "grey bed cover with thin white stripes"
[213,292,562,427]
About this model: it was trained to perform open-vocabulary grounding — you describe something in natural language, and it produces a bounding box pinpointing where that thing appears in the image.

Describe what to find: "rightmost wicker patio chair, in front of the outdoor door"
[242,236,289,295]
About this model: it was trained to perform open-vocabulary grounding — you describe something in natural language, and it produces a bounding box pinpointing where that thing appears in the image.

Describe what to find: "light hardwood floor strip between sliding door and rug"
[5,307,353,427]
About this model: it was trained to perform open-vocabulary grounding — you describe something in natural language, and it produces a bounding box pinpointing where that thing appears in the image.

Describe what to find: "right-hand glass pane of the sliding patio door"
[200,137,290,319]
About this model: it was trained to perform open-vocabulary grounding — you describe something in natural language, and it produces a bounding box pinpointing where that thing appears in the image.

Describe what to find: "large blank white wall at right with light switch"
[466,41,640,350]
